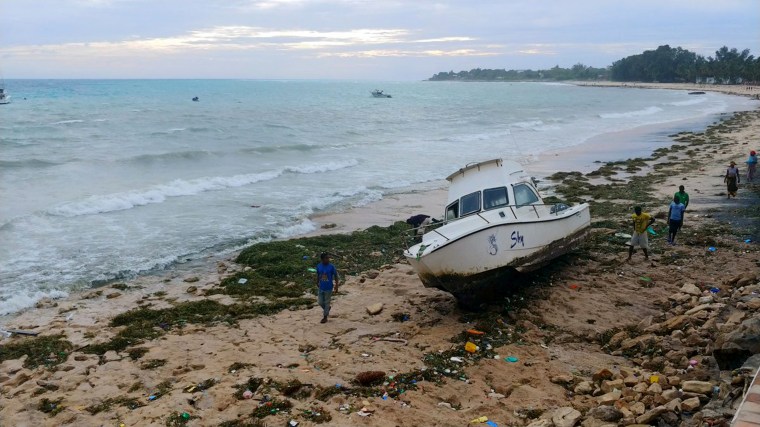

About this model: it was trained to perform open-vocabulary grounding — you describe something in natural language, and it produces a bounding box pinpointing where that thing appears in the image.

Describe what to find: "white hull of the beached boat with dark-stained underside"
[406,206,591,296]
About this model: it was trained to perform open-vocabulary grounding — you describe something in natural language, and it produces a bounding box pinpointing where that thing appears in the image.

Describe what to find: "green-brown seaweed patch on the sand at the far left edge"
[0,335,73,369]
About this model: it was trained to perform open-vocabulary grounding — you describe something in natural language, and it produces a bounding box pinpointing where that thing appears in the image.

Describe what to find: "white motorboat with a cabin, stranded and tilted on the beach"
[404,159,591,306]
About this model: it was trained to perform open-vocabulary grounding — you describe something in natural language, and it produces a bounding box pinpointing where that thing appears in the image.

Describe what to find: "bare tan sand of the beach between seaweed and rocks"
[0,86,760,426]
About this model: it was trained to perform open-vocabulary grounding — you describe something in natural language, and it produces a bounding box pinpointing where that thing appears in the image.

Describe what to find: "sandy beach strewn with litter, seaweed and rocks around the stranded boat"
[0,88,760,427]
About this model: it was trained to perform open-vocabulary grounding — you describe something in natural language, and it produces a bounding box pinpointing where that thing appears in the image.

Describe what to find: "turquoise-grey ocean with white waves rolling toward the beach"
[0,80,756,315]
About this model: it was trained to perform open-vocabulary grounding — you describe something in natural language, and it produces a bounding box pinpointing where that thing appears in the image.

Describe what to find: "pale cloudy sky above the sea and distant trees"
[0,0,760,81]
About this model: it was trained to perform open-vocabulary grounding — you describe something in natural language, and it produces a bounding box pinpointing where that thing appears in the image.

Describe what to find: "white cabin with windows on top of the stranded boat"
[446,159,543,221]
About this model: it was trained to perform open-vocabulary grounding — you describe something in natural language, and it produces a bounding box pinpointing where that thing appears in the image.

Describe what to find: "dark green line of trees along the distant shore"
[429,45,760,84]
